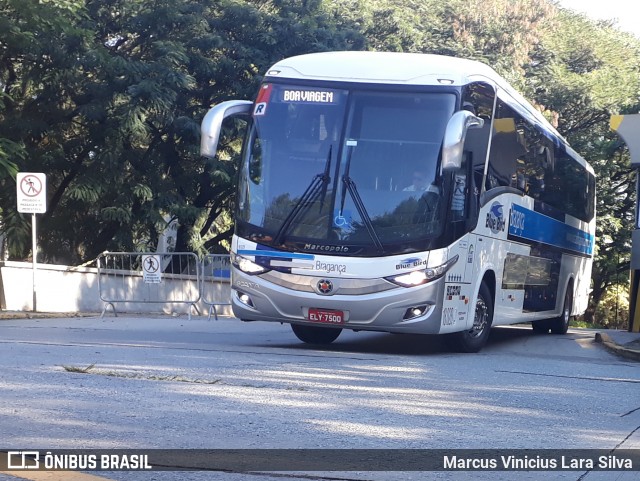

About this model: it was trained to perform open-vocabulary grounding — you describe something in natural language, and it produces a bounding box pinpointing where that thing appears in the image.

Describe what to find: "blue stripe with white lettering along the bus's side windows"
[509,204,594,256]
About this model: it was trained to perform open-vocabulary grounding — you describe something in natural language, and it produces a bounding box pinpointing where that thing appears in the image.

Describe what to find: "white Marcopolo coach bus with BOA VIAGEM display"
[201,52,595,352]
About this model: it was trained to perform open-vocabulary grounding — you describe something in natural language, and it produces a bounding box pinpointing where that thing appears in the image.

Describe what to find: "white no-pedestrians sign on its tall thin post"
[16,172,47,312]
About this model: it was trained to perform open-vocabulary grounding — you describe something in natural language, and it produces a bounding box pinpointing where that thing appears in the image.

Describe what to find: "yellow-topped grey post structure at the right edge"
[610,114,640,332]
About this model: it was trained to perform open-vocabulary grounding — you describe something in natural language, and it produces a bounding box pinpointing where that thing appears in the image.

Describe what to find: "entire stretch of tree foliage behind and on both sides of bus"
[0,0,640,324]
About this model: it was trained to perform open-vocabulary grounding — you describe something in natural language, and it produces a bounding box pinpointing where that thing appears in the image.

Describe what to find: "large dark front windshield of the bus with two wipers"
[237,84,456,255]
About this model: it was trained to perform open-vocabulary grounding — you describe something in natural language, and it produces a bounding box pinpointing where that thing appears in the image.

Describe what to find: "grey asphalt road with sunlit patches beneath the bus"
[0,317,640,481]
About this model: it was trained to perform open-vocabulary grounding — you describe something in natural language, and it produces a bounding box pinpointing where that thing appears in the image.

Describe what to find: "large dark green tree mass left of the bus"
[0,0,356,263]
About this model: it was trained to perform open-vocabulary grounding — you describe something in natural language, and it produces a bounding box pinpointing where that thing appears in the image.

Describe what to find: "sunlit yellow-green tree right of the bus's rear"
[527,6,640,322]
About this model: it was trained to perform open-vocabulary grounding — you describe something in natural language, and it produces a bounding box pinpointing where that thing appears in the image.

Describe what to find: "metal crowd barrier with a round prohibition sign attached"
[97,252,201,319]
